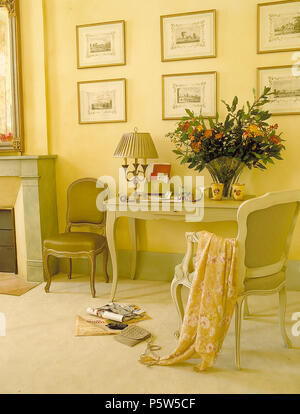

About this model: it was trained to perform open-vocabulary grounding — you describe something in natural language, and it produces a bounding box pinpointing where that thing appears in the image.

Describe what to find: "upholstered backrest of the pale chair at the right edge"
[237,190,300,287]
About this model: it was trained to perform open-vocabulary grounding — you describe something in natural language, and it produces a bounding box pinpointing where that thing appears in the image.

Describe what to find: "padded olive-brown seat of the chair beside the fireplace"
[44,232,106,253]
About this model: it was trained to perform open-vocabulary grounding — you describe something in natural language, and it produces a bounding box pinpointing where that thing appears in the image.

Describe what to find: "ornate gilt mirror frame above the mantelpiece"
[0,0,24,153]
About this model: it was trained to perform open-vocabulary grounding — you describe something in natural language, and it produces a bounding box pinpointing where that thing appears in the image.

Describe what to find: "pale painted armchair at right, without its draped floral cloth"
[171,190,300,369]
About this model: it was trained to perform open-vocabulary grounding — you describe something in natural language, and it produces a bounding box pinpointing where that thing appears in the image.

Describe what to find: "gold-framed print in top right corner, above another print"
[257,0,300,53]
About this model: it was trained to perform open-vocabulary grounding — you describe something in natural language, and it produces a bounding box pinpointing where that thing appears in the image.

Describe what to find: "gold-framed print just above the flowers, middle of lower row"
[162,71,218,121]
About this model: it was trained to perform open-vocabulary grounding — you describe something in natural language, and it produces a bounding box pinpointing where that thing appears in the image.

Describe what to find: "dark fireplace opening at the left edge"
[0,208,18,274]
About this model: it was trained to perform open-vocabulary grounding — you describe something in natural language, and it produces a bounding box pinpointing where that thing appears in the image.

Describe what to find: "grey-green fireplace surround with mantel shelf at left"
[0,155,58,282]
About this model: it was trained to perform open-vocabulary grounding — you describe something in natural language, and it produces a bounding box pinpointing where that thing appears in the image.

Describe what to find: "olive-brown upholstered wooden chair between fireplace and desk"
[43,178,109,297]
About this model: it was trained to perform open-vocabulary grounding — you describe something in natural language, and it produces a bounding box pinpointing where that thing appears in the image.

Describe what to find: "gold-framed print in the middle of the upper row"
[160,9,217,62]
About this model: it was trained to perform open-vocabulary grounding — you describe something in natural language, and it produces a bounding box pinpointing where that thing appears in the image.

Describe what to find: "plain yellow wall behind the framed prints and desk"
[21,0,300,259]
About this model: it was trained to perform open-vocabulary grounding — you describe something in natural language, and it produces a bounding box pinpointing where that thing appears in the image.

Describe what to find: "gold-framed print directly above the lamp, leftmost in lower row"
[78,79,127,124]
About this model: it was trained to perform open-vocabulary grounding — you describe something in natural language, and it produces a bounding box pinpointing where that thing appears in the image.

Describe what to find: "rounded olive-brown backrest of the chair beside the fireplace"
[67,178,107,231]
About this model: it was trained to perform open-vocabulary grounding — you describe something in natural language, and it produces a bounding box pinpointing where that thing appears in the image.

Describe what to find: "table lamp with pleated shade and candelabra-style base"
[114,128,158,190]
